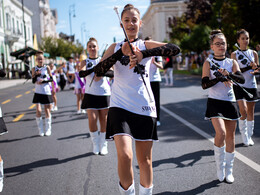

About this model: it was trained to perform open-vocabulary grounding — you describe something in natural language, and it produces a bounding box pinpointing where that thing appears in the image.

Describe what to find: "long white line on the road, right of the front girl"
[161,106,260,173]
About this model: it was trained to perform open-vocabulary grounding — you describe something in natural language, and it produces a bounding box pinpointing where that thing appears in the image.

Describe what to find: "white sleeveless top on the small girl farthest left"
[35,65,51,95]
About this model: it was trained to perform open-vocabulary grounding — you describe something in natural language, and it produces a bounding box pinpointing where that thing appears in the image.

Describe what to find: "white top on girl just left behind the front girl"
[85,57,111,95]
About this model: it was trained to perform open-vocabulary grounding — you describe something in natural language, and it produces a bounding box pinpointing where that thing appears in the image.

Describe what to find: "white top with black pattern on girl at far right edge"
[235,49,257,88]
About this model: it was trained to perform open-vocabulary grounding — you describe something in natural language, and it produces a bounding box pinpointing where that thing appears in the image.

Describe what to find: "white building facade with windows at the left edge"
[0,0,33,70]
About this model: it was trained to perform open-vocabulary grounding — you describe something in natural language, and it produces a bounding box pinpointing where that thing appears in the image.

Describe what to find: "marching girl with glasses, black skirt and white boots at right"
[202,30,245,183]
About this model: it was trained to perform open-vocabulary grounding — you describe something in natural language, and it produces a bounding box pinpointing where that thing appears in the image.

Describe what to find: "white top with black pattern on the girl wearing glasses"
[208,58,236,102]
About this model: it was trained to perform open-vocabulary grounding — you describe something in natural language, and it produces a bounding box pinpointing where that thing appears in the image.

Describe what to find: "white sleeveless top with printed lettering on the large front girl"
[110,40,157,117]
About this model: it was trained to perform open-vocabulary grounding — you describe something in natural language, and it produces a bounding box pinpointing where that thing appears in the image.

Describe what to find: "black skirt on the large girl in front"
[106,107,158,141]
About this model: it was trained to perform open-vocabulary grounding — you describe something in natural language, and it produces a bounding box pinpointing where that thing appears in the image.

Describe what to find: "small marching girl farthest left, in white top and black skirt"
[32,52,53,136]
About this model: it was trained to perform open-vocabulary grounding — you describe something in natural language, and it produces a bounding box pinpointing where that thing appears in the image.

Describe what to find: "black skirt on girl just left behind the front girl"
[81,93,110,110]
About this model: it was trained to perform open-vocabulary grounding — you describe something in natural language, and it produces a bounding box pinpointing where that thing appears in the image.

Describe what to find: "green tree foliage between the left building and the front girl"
[40,37,84,59]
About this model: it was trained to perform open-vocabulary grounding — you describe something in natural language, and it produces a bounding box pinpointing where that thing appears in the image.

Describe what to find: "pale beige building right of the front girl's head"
[139,0,187,41]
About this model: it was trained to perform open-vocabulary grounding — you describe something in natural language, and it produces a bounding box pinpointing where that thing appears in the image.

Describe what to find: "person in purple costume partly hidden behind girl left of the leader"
[74,60,86,114]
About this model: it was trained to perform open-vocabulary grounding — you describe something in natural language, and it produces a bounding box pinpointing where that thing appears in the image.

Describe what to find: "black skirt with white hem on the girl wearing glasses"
[205,98,241,120]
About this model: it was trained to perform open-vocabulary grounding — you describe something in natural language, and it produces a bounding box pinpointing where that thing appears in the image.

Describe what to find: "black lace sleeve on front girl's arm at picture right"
[141,43,180,58]
